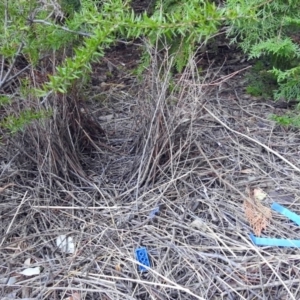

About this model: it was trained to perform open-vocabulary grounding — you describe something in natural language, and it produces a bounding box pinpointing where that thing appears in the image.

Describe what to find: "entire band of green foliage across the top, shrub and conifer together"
[0,0,300,131]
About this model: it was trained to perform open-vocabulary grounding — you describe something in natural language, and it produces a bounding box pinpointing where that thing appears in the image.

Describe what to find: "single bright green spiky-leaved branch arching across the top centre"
[39,0,227,93]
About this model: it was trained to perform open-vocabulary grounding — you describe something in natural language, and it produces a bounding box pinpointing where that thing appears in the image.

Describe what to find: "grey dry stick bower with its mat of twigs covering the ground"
[0,50,300,300]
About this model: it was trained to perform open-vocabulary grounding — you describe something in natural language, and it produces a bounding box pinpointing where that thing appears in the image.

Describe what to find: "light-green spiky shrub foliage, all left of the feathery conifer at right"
[0,0,223,132]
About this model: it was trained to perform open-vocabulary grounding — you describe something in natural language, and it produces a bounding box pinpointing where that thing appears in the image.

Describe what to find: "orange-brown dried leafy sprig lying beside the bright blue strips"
[244,201,272,236]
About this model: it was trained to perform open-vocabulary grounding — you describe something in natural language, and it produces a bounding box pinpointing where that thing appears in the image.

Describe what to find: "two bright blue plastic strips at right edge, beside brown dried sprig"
[250,202,300,248]
